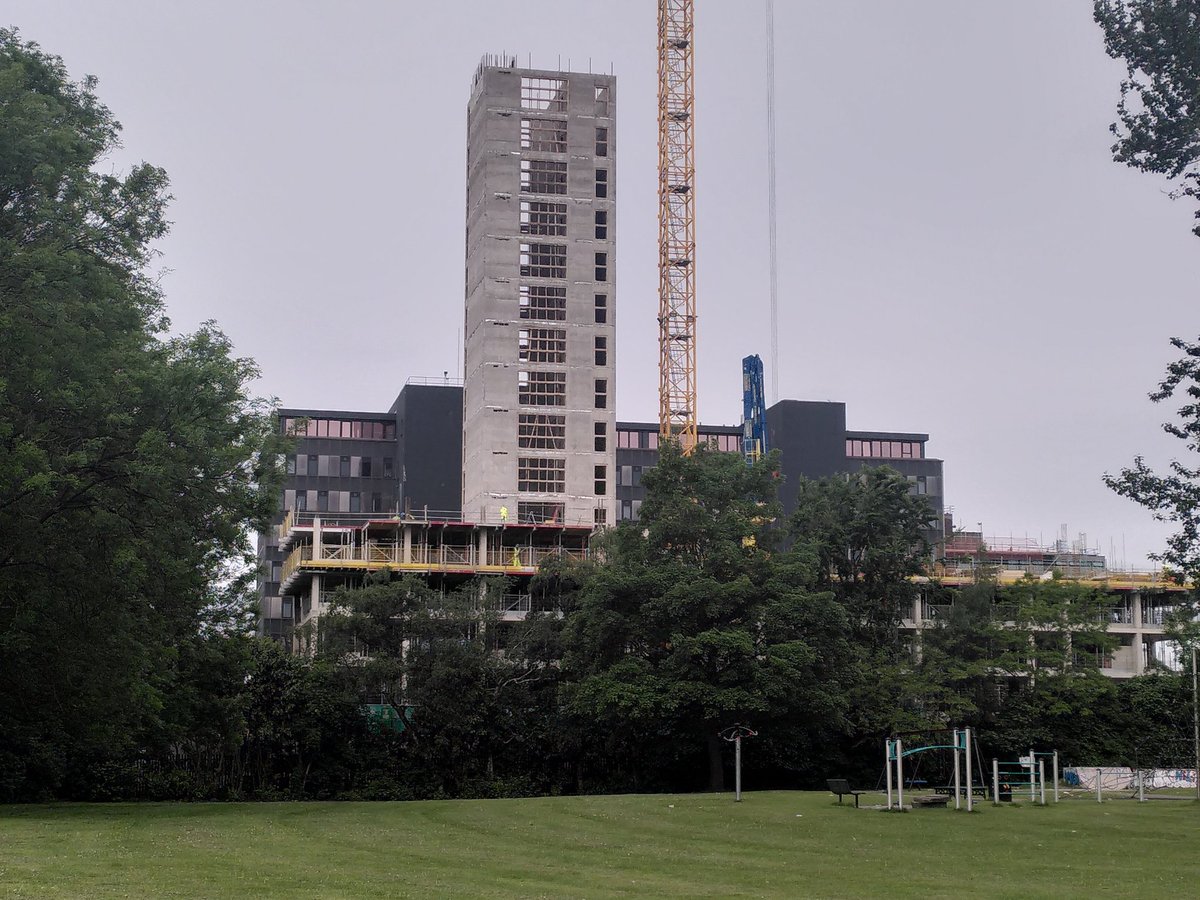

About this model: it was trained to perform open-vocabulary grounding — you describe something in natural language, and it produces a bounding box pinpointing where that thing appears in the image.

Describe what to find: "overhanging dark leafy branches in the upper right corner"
[1093,0,1200,235]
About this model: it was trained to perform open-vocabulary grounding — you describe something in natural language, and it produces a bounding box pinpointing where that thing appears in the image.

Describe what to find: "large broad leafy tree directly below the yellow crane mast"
[564,444,854,790]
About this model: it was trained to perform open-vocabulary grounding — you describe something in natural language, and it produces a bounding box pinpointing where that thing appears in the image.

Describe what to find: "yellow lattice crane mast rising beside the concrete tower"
[659,0,697,454]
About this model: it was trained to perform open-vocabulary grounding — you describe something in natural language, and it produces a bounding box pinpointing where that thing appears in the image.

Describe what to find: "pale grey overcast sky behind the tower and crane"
[7,0,1200,565]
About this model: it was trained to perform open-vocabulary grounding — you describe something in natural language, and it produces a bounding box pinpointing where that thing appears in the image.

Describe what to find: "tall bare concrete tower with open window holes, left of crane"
[462,58,617,526]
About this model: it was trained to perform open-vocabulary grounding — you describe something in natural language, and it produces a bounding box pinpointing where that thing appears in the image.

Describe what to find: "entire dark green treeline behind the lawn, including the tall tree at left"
[0,30,1190,800]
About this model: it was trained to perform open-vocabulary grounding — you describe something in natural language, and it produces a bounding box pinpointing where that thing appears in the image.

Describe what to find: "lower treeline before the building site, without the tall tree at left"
[8,448,1190,799]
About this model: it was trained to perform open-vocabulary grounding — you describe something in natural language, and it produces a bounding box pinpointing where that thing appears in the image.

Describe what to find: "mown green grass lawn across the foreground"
[0,792,1200,898]
